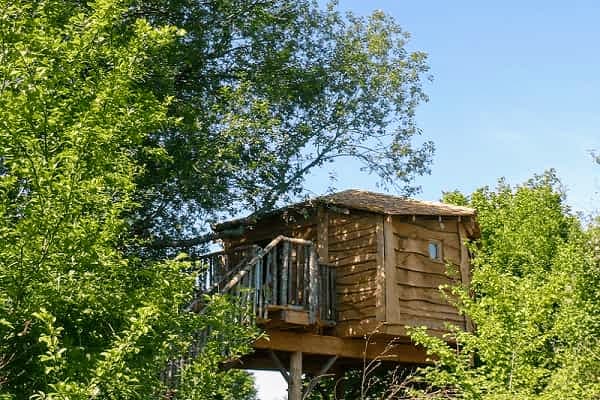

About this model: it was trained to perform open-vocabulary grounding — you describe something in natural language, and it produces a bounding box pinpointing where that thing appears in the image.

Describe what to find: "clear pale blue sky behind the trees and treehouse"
[258,0,600,400]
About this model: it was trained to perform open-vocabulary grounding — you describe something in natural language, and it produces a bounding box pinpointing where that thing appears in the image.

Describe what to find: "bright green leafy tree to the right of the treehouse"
[413,172,600,399]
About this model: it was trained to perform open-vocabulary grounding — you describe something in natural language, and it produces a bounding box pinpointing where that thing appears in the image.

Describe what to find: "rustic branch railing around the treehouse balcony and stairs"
[199,236,335,324]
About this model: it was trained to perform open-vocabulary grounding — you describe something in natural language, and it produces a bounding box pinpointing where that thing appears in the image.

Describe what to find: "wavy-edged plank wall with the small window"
[385,216,468,333]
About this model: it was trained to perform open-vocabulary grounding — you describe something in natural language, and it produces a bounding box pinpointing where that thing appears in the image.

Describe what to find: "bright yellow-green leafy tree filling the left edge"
[0,0,253,399]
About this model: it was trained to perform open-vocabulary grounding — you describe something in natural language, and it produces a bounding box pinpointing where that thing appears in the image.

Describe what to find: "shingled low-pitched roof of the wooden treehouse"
[215,189,476,231]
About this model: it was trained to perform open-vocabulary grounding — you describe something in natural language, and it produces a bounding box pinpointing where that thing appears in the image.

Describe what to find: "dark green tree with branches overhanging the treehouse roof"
[124,0,433,256]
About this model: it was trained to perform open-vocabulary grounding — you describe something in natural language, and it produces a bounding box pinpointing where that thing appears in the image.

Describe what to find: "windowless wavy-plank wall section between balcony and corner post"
[327,210,382,336]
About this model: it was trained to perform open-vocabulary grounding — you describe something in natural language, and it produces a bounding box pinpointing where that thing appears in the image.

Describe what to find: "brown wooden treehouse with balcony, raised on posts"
[200,190,478,399]
